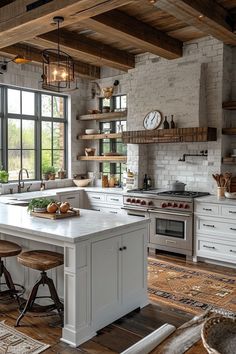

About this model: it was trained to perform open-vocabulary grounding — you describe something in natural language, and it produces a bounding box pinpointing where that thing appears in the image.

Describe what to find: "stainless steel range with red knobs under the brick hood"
[123,189,209,256]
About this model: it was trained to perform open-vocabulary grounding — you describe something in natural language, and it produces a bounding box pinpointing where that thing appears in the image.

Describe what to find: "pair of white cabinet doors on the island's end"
[91,230,147,328]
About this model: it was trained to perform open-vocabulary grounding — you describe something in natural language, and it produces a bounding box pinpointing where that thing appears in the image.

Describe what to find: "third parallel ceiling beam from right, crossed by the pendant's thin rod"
[27,30,135,71]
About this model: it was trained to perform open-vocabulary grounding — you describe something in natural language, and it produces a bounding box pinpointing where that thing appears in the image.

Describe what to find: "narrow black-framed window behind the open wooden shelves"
[99,95,127,183]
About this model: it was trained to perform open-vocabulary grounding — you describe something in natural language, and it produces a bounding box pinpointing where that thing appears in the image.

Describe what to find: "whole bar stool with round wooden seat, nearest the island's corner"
[16,250,64,327]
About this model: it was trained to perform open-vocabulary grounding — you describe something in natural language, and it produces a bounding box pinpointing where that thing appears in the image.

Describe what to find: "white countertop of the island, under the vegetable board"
[0,203,149,243]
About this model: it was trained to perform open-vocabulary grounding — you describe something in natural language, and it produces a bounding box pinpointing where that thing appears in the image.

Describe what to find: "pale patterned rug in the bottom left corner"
[0,321,50,354]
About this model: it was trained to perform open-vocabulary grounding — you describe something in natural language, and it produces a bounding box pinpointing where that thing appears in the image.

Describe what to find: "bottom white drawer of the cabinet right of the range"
[197,239,236,262]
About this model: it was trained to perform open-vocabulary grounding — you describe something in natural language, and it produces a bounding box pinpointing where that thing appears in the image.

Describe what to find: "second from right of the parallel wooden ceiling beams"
[84,10,182,59]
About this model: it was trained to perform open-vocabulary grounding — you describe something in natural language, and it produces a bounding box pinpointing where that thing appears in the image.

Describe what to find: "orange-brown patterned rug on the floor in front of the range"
[148,258,236,316]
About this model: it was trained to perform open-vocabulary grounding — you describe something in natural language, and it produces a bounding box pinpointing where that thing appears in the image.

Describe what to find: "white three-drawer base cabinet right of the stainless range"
[195,196,236,266]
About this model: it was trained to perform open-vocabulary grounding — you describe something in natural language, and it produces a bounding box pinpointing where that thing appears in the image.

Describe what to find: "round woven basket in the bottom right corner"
[201,316,236,354]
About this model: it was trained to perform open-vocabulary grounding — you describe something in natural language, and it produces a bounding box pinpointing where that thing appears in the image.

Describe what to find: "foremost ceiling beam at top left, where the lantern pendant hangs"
[0,0,134,48]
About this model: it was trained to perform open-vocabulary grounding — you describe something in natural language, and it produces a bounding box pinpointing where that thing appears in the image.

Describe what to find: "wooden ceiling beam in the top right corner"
[155,0,236,45]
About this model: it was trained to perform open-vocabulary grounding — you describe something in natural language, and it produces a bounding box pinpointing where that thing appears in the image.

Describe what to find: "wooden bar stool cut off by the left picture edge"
[0,240,25,304]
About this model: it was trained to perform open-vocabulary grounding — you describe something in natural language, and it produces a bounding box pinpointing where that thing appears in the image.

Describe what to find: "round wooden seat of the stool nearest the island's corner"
[17,250,64,271]
